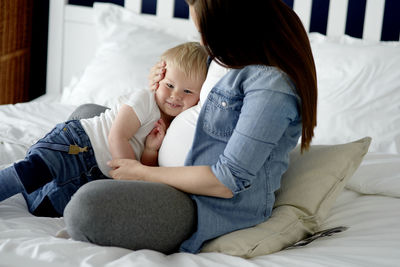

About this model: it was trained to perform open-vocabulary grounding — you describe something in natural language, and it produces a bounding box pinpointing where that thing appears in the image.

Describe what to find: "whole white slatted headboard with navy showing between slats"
[46,0,400,94]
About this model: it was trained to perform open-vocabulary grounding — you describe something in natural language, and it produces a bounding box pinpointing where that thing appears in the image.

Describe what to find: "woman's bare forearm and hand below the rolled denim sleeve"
[109,159,233,198]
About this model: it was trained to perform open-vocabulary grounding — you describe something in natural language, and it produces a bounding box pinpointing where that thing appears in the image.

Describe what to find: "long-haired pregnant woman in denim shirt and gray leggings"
[64,0,317,253]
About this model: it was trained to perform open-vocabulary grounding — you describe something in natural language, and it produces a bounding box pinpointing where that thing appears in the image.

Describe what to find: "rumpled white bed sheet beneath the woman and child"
[0,98,400,267]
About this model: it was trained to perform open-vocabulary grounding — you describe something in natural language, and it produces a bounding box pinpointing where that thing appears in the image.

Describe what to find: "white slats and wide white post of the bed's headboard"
[46,0,396,94]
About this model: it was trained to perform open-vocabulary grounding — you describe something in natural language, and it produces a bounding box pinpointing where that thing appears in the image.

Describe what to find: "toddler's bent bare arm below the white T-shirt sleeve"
[108,104,140,159]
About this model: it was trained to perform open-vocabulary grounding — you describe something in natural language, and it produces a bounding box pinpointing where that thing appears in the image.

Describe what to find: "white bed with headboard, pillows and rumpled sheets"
[0,0,400,267]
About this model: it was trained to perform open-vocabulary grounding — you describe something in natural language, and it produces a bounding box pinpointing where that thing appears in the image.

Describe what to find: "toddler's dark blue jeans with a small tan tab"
[0,120,107,215]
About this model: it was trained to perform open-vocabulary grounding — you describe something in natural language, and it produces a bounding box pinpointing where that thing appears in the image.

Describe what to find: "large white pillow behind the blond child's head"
[61,3,195,107]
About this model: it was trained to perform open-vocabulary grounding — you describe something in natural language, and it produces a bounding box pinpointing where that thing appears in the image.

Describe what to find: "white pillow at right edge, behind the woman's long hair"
[310,34,400,154]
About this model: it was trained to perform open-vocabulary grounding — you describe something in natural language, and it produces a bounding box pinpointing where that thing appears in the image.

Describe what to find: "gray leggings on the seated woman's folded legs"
[64,105,196,254]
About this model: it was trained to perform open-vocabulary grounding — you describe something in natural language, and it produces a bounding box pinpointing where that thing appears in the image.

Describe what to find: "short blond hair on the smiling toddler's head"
[161,42,208,83]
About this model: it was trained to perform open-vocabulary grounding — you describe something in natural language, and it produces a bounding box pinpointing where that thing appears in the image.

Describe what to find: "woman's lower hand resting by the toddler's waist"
[107,159,143,180]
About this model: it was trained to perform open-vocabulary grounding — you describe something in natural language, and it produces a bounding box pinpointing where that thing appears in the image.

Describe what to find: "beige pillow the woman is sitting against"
[202,137,371,258]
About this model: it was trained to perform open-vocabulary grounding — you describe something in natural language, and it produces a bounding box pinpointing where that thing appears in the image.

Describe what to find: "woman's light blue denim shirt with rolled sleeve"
[180,65,302,253]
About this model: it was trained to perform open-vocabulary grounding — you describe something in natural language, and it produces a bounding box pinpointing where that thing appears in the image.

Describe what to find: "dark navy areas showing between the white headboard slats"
[69,0,400,41]
